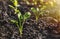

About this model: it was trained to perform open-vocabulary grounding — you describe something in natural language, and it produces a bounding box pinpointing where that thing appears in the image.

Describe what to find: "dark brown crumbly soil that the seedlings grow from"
[0,0,60,39]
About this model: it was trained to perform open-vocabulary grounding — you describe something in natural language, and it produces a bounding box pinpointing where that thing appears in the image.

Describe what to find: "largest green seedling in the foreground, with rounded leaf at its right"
[9,0,31,35]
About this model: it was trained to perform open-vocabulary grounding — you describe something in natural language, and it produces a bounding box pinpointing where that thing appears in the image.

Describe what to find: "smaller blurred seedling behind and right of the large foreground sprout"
[31,7,46,22]
